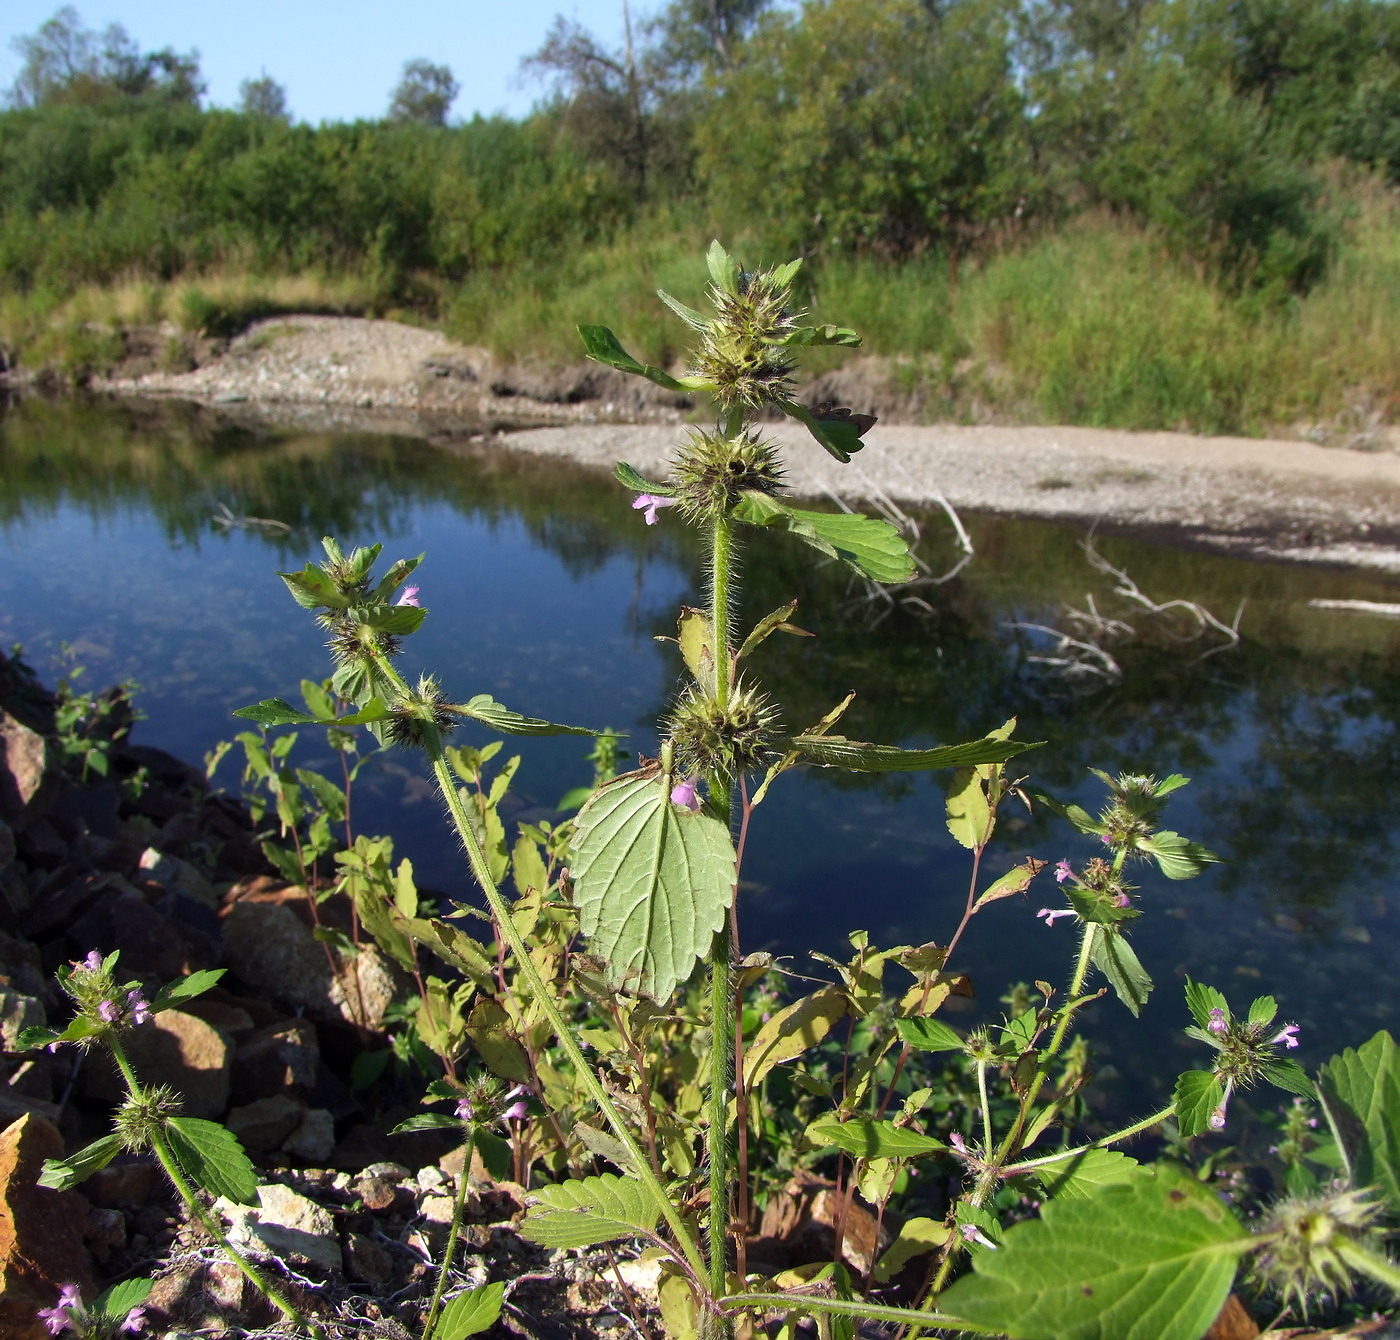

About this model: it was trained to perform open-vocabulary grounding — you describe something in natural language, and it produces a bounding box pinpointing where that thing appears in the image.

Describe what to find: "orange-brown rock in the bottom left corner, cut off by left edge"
[0,1115,92,1340]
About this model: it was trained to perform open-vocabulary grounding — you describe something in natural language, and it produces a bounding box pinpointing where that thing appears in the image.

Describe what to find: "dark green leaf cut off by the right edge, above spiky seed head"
[1317,1029,1400,1214]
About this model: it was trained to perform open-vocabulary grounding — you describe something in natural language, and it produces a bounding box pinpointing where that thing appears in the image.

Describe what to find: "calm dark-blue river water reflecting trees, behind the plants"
[0,402,1400,1103]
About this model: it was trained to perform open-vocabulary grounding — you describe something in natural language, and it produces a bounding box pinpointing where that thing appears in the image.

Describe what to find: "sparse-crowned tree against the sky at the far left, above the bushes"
[8,4,204,106]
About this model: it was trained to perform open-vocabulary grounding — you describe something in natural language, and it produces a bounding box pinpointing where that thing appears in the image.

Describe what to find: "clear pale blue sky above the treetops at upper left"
[0,0,632,123]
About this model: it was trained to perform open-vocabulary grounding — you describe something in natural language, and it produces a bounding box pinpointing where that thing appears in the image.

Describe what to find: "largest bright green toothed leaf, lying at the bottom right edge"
[938,1171,1250,1340]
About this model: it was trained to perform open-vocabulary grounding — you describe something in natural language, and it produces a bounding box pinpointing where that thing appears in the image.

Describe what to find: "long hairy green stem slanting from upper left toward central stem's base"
[379,662,704,1280]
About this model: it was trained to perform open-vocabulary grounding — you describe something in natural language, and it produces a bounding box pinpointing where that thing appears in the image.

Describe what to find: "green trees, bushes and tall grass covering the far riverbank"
[8,0,1400,440]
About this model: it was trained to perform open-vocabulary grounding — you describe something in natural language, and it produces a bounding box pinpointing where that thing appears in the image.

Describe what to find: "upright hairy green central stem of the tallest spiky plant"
[704,514,745,1340]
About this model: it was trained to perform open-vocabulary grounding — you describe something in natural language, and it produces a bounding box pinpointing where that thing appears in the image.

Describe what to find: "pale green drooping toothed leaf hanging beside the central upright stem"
[570,774,735,1001]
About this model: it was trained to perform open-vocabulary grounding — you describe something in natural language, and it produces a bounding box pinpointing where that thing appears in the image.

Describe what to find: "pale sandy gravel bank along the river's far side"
[79,316,1400,574]
